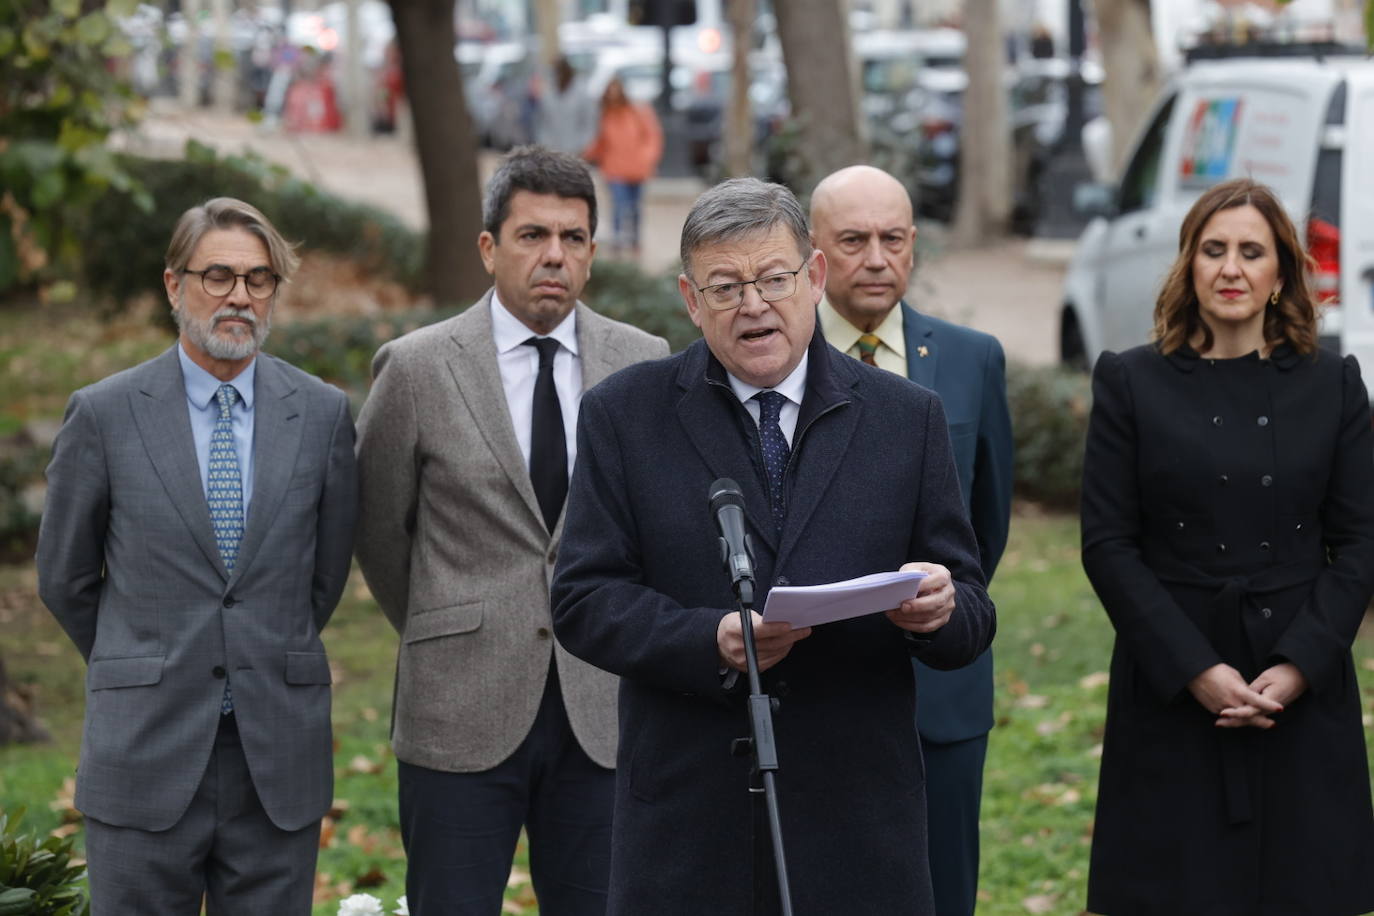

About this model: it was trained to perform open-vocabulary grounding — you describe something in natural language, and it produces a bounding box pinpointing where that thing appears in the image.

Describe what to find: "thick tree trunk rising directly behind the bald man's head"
[774,0,868,196]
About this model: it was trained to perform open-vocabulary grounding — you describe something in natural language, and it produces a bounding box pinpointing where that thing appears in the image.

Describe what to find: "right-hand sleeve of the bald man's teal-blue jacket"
[969,341,1013,582]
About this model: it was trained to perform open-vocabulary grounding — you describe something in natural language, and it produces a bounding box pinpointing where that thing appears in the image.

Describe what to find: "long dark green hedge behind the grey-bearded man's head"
[73,140,425,306]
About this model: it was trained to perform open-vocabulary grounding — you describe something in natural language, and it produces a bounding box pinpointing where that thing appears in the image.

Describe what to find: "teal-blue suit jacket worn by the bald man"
[900,302,1013,743]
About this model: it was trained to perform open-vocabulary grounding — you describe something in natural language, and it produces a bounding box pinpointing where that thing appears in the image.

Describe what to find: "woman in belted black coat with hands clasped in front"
[1083,180,1374,916]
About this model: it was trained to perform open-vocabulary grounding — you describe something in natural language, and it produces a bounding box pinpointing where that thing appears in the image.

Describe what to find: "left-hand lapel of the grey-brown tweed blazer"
[447,298,544,530]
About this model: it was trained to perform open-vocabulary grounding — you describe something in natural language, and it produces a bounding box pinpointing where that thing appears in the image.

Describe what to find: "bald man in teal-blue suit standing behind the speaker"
[811,165,1011,916]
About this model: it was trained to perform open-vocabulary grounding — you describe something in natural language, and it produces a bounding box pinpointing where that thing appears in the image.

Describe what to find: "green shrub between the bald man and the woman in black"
[1007,363,1092,511]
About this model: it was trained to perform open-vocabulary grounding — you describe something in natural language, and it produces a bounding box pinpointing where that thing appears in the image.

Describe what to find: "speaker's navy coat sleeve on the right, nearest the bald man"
[907,387,998,670]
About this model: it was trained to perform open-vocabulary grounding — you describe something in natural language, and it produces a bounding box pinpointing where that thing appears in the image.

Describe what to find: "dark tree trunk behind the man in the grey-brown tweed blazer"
[390,0,489,306]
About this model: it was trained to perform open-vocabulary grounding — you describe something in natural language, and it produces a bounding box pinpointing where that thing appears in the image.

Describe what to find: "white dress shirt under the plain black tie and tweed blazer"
[492,290,583,479]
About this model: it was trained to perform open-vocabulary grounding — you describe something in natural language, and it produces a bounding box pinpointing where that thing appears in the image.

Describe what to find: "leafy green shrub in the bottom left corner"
[0,810,91,916]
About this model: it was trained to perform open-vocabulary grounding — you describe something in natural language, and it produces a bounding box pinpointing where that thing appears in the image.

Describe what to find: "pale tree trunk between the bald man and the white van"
[954,0,1011,246]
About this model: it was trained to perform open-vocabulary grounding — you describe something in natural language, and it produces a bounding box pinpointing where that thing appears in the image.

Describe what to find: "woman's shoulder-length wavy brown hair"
[1153,179,1316,353]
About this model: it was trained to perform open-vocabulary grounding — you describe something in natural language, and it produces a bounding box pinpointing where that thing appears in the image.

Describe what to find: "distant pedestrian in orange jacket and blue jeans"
[583,77,664,260]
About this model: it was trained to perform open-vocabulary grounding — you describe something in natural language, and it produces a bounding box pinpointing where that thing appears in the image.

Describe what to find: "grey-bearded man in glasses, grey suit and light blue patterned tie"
[37,198,357,916]
